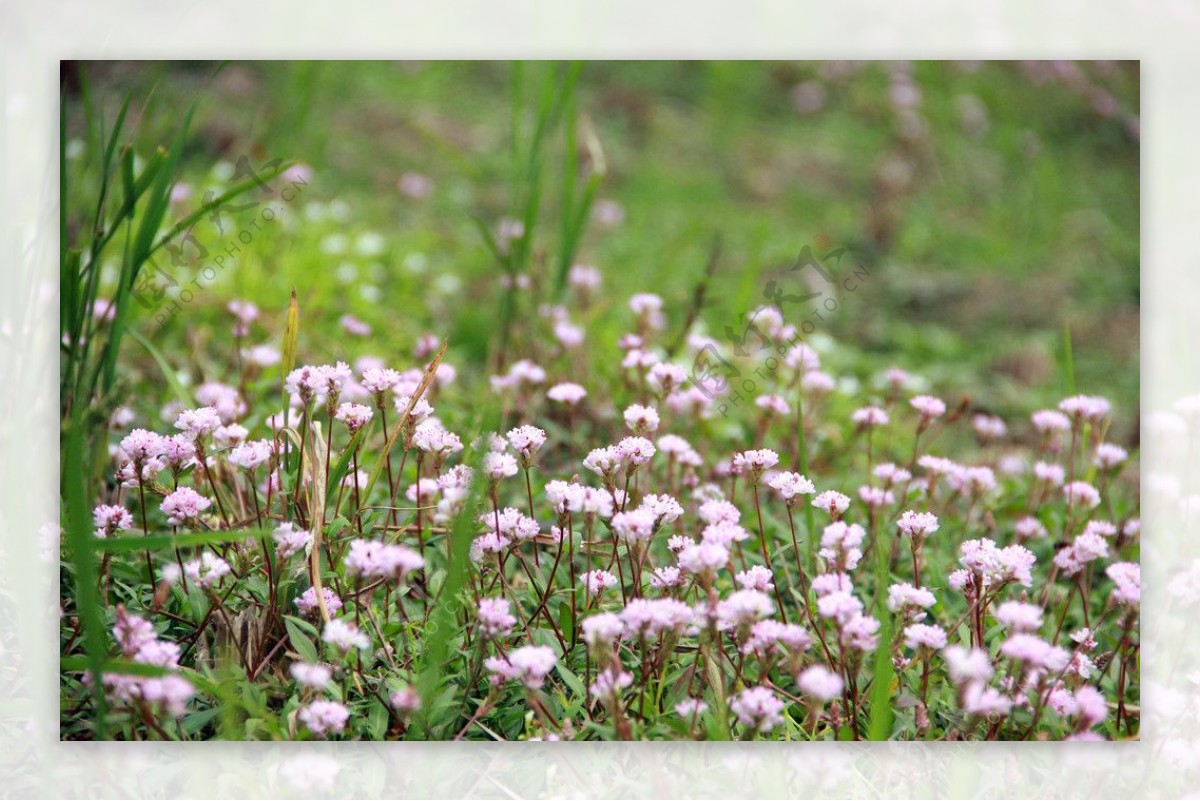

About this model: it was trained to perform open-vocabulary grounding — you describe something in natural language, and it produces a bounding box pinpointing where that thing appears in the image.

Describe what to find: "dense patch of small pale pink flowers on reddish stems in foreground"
[64,275,1132,741]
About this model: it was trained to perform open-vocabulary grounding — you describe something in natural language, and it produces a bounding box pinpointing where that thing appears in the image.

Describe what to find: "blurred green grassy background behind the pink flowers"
[64,61,1140,439]
